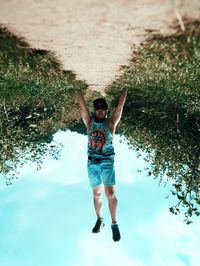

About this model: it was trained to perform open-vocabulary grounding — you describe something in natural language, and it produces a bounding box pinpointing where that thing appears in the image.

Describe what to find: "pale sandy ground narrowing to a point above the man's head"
[0,0,200,91]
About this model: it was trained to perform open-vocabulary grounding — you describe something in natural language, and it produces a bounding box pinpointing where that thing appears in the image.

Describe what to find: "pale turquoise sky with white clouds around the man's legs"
[0,131,200,266]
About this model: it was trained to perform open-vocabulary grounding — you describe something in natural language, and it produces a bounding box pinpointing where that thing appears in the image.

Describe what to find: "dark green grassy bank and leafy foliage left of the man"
[0,27,87,184]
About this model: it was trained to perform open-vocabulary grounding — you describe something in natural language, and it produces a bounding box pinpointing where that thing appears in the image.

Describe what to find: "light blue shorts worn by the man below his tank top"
[87,159,115,188]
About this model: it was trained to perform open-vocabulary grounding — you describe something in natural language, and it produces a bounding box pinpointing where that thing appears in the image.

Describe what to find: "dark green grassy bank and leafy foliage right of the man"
[108,20,200,223]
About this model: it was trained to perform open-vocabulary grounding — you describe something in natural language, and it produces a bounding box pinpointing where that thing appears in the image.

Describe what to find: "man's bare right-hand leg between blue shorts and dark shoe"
[105,186,117,223]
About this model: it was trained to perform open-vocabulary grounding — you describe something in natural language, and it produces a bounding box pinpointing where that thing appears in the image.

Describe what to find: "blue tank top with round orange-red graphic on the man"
[88,118,115,158]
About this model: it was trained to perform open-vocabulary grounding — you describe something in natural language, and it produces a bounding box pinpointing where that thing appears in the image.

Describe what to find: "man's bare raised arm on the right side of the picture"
[110,89,127,129]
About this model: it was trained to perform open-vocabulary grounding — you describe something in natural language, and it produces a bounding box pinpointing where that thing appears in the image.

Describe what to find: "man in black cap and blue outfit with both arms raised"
[78,89,127,241]
